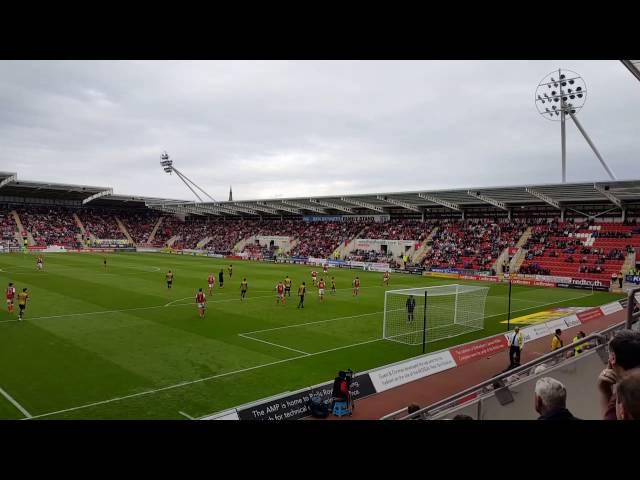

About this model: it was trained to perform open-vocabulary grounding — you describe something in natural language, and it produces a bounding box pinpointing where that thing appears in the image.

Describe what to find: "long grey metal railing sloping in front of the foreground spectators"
[381,322,640,420]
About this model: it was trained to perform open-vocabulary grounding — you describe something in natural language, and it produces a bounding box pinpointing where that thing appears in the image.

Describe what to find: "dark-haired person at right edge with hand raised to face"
[598,330,640,420]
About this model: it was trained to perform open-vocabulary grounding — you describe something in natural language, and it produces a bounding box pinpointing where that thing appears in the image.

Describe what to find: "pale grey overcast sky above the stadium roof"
[0,60,640,200]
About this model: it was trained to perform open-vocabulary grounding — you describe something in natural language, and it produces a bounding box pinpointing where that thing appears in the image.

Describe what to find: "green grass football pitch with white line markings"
[0,253,620,419]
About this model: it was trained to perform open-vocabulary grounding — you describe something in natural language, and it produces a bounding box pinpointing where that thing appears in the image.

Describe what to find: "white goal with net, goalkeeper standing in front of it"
[382,284,489,345]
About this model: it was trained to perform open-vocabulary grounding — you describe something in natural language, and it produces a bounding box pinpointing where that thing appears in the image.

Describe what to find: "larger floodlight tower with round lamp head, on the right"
[535,69,616,183]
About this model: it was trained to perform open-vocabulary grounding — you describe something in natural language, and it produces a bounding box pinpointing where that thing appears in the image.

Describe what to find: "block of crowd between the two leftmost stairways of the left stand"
[16,206,80,248]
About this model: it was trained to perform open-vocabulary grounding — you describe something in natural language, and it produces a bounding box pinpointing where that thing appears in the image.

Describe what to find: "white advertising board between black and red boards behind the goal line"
[369,351,456,392]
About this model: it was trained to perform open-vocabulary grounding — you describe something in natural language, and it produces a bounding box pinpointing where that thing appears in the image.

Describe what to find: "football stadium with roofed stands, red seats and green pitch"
[0,61,640,421]
